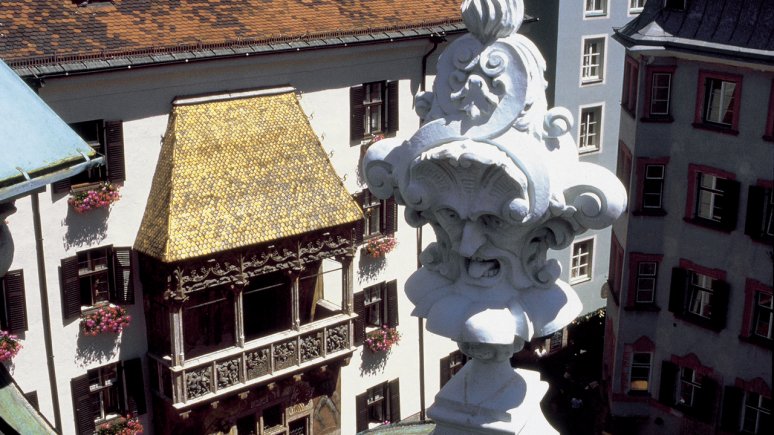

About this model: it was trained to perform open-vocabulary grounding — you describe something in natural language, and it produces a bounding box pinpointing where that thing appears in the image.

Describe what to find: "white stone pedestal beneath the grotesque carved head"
[427,359,558,435]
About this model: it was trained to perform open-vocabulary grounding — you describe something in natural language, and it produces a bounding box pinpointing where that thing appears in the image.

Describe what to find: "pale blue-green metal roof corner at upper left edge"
[0,61,101,202]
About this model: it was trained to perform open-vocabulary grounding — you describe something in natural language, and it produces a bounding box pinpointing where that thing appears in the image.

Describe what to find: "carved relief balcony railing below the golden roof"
[148,314,354,409]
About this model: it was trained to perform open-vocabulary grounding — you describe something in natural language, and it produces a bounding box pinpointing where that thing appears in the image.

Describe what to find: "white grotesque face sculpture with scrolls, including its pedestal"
[363,0,626,434]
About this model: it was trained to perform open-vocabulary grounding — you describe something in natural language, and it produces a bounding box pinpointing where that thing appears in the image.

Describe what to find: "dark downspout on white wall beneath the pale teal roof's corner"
[30,192,62,433]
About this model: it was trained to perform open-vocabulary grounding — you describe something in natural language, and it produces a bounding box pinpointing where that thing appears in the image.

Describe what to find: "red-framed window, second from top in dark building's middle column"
[686,164,739,231]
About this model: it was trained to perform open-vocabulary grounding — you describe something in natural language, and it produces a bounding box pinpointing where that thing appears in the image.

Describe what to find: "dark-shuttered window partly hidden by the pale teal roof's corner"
[52,119,126,193]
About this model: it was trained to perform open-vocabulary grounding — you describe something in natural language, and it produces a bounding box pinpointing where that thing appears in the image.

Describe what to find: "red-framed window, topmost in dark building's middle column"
[694,71,742,132]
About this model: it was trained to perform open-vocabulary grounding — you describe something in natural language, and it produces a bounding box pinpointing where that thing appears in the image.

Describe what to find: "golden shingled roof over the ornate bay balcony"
[134,90,363,262]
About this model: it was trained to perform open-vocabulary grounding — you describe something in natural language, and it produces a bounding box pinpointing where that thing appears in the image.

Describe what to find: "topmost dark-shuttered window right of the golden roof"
[350,81,398,143]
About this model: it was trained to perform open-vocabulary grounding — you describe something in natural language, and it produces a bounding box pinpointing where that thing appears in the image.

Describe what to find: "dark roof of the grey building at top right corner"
[616,0,774,60]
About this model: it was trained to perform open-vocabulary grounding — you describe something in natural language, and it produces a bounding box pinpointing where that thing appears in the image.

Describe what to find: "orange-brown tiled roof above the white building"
[0,0,463,75]
